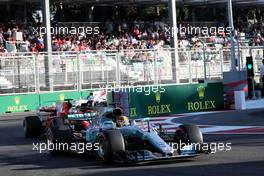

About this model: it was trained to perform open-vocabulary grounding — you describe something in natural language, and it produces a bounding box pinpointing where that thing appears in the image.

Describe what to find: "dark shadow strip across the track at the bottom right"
[72,161,264,176]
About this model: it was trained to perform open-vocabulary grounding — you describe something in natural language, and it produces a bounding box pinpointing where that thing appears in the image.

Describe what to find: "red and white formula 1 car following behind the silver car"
[23,99,97,140]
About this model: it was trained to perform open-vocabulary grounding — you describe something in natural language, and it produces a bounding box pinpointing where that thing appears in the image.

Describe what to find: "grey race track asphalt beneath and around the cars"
[0,111,264,176]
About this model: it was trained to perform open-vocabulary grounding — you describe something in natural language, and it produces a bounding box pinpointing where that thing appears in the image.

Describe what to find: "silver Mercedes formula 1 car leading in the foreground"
[46,108,210,163]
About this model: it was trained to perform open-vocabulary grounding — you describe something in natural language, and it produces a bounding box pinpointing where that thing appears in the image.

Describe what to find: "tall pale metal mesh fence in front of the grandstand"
[0,47,263,94]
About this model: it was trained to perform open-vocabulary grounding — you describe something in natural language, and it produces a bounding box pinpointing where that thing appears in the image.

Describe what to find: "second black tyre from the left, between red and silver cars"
[46,118,73,155]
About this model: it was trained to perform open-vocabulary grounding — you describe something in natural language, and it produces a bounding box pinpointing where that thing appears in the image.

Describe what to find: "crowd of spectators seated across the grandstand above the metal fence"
[0,21,264,53]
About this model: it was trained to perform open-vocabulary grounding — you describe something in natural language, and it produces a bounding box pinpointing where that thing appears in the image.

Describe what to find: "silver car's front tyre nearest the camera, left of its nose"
[97,130,125,162]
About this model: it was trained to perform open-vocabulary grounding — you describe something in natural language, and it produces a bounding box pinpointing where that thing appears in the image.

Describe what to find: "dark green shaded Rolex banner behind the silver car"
[129,83,224,118]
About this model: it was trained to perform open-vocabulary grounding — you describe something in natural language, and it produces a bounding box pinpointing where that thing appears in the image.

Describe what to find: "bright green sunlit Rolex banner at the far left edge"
[0,94,39,113]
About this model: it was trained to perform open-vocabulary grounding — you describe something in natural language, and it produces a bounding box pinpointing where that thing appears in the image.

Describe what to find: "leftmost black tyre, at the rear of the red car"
[23,116,42,138]
